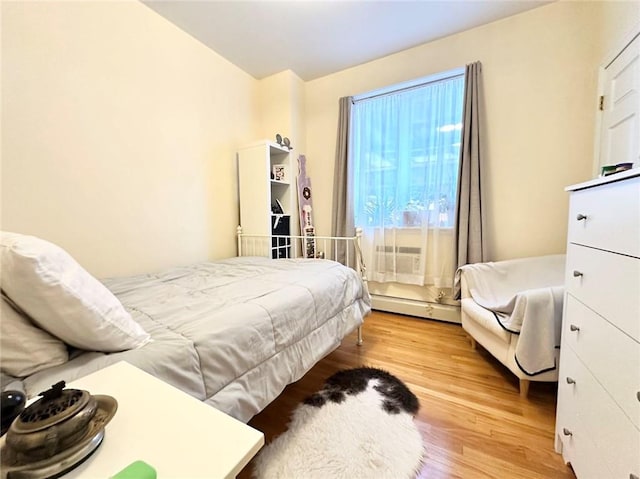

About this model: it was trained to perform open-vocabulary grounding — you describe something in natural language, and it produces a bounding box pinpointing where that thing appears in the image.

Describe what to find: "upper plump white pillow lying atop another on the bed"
[0,232,150,352]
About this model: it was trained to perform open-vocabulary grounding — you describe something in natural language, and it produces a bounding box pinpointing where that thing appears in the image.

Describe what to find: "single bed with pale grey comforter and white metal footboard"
[2,230,370,422]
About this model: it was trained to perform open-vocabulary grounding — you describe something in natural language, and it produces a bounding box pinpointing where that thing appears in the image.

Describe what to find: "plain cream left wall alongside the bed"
[1,1,257,277]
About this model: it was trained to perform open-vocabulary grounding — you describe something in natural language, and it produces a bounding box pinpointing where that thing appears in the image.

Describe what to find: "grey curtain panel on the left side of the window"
[331,96,355,263]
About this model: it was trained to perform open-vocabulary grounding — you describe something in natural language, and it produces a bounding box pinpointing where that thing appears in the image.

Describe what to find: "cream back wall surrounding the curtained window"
[306,2,635,260]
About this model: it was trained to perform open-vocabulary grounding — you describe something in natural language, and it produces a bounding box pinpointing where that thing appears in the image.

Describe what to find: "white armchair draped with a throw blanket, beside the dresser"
[456,255,565,398]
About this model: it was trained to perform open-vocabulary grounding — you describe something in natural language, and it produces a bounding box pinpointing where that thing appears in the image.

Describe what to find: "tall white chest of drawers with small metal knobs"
[555,169,640,479]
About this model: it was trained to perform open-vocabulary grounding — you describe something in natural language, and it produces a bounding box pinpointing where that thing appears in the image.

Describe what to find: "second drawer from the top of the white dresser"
[565,244,640,341]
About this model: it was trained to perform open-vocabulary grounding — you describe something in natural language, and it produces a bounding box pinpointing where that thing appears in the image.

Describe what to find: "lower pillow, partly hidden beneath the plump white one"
[0,297,69,378]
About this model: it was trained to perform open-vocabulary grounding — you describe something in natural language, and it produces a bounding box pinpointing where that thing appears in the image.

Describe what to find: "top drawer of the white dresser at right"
[568,177,640,257]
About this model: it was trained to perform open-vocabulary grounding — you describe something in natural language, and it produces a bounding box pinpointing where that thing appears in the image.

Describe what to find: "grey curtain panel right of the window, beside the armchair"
[453,62,487,299]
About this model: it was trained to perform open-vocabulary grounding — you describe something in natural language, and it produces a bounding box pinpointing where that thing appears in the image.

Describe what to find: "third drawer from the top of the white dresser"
[562,294,640,428]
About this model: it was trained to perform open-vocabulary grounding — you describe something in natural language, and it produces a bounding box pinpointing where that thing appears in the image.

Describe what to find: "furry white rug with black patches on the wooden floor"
[253,368,424,479]
